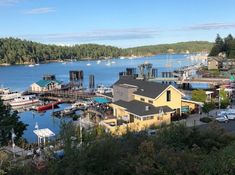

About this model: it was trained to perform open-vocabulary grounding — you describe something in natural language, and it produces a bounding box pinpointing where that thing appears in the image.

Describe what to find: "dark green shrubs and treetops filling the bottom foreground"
[6,123,235,175]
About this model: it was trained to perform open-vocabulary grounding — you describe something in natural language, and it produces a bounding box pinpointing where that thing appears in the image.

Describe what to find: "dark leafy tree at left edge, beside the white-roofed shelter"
[0,99,27,146]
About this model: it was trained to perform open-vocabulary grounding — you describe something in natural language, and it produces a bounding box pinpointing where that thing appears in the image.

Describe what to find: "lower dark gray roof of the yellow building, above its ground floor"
[113,100,173,116]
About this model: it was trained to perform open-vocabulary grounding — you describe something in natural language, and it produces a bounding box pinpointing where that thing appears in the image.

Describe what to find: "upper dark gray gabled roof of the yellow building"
[114,76,169,98]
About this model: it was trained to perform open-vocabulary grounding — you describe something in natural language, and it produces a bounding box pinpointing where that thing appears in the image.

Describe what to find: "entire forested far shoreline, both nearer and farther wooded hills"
[0,38,212,64]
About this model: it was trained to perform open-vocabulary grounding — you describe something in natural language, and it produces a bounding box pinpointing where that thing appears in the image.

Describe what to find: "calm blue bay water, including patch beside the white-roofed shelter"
[0,54,205,142]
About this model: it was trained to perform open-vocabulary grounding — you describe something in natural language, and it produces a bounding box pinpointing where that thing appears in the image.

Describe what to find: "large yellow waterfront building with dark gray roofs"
[101,77,183,135]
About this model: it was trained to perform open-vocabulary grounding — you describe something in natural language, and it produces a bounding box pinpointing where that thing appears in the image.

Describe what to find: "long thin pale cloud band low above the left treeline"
[18,28,159,43]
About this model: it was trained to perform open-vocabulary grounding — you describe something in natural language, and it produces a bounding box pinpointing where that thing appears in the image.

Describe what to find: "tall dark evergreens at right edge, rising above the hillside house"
[209,34,235,58]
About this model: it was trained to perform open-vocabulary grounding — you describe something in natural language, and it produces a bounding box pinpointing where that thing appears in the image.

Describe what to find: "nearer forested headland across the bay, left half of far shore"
[0,38,122,64]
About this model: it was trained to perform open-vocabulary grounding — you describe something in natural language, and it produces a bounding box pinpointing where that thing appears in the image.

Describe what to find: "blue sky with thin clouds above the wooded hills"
[0,0,235,48]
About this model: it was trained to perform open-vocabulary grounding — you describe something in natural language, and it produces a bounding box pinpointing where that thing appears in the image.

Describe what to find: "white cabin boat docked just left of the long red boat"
[9,95,39,108]
